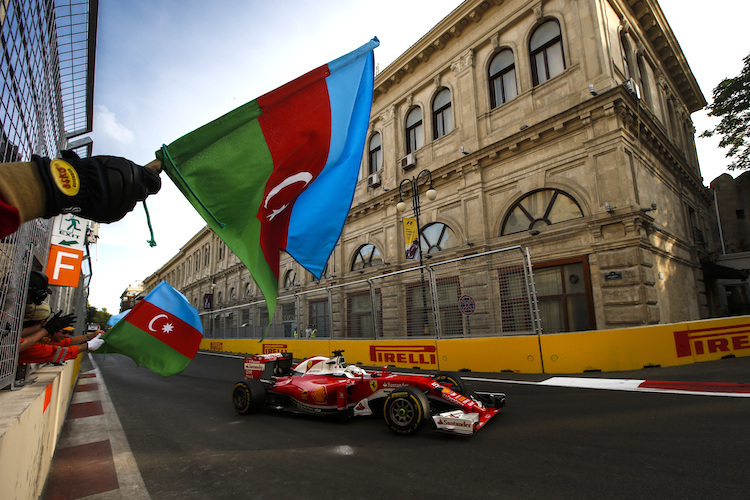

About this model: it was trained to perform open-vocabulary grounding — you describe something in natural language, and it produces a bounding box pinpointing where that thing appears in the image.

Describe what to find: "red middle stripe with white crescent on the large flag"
[256,65,331,280]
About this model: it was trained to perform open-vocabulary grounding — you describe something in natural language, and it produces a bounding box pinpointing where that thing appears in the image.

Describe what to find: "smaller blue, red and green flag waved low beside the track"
[102,281,203,377]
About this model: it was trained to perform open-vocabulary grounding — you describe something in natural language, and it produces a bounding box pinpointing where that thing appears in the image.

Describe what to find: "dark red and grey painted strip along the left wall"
[41,353,150,500]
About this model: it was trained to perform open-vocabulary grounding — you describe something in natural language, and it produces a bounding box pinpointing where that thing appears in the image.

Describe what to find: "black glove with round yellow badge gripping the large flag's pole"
[31,151,161,222]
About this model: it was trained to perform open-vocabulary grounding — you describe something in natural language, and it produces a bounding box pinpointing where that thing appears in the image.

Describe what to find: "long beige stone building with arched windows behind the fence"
[144,0,710,332]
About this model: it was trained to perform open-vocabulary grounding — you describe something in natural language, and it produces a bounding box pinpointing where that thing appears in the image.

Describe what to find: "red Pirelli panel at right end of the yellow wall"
[674,325,750,358]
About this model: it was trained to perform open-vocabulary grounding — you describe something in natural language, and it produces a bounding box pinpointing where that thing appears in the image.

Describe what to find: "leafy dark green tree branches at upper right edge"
[700,55,750,170]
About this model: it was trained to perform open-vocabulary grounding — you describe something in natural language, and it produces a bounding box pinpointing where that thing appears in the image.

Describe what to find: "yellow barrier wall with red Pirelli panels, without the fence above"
[201,316,750,373]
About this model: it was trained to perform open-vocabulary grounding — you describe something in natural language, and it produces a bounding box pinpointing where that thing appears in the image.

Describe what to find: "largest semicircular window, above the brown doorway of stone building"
[500,189,583,236]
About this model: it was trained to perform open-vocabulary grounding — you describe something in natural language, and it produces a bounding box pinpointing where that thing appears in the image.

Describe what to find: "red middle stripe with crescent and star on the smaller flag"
[123,300,203,359]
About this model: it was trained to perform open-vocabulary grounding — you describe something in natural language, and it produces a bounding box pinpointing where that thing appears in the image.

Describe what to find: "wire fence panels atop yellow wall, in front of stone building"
[202,247,541,339]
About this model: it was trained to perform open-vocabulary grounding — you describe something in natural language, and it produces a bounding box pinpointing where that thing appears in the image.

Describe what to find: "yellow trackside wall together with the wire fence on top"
[201,247,750,373]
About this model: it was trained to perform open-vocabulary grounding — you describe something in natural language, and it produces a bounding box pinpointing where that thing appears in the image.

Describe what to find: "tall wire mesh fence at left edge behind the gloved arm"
[0,0,98,389]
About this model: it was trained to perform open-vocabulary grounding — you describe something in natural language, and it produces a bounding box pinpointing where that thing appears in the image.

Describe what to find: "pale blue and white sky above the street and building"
[89,0,750,313]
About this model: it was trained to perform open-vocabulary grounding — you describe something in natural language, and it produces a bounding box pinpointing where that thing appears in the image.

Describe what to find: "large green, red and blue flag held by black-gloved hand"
[157,38,379,316]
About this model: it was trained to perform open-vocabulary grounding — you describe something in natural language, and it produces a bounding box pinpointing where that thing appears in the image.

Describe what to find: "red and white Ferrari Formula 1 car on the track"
[232,351,505,434]
